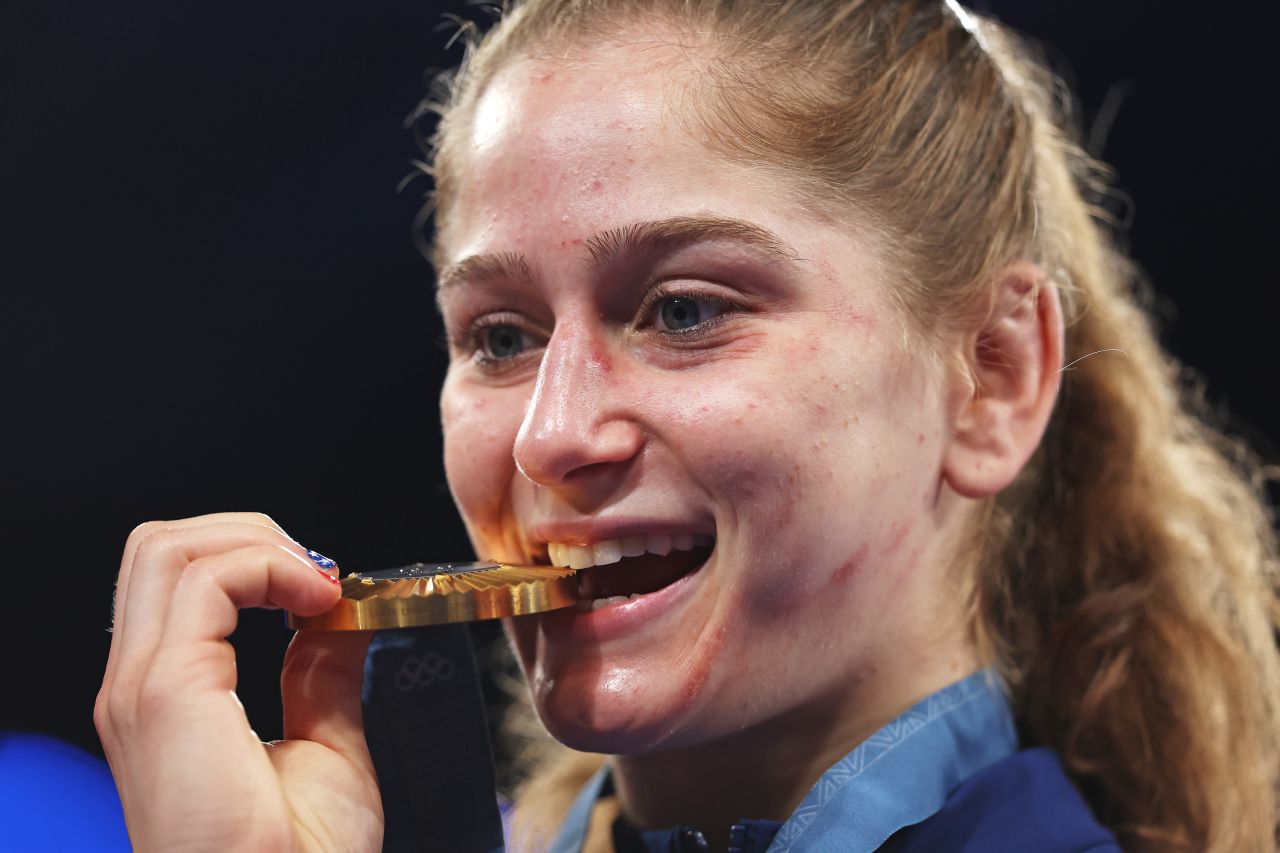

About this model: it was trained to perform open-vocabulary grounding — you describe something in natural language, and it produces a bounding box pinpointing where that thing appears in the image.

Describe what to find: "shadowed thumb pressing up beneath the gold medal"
[280,630,374,775]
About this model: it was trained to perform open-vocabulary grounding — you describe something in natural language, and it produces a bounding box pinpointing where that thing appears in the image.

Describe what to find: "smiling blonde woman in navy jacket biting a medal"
[96,0,1280,850]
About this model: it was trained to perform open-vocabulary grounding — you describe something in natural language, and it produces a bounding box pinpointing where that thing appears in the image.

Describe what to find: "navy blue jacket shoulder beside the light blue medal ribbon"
[881,747,1120,853]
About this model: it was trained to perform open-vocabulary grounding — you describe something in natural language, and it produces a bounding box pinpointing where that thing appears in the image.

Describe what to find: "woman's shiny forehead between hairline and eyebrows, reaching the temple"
[436,35,892,326]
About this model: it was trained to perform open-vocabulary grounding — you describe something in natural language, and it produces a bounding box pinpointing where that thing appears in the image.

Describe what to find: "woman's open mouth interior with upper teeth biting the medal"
[532,534,716,610]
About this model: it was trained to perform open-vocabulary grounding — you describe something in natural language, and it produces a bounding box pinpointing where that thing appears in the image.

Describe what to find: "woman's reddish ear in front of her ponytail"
[942,263,1064,498]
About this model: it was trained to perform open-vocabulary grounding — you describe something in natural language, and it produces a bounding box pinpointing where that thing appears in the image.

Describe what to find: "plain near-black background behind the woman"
[0,0,1280,751]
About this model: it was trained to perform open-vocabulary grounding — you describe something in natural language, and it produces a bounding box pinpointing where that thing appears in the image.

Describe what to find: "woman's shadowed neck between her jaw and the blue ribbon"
[613,644,979,850]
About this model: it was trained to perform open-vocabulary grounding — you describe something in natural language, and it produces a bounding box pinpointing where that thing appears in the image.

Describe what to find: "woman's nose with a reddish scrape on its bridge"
[515,320,644,489]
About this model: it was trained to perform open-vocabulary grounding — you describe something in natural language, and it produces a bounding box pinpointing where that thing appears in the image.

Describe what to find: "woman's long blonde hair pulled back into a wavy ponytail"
[426,0,1280,852]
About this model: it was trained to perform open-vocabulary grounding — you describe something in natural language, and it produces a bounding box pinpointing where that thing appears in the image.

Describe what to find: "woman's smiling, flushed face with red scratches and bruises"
[439,36,962,753]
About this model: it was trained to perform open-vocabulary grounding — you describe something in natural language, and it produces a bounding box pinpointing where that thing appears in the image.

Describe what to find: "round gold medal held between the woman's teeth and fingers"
[289,562,577,631]
